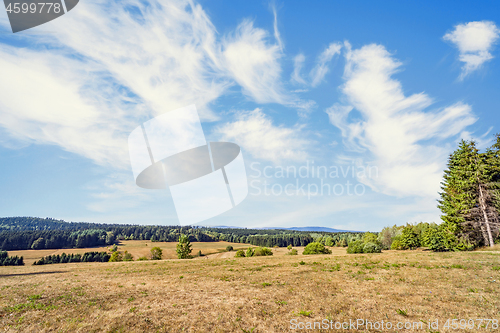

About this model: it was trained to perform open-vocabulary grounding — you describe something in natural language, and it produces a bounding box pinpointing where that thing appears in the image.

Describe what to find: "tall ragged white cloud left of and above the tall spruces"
[327,43,476,197]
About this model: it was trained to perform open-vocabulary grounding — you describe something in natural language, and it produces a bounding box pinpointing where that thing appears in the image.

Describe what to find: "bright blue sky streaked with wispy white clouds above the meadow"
[0,0,500,231]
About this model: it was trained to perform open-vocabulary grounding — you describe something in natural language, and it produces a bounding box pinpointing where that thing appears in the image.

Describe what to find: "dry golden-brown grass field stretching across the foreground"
[0,241,500,333]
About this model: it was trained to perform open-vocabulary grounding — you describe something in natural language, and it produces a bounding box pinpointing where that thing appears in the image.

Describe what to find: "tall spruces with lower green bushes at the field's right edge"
[376,134,500,251]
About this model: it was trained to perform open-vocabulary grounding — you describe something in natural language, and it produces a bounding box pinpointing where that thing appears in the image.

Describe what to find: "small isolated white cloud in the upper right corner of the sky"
[443,21,500,80]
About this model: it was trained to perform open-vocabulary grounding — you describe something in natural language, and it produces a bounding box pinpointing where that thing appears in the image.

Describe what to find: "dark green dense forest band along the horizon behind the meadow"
[0,217,361,251]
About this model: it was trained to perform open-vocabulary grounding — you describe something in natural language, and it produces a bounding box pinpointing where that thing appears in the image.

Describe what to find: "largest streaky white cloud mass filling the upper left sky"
[0,0,308,168]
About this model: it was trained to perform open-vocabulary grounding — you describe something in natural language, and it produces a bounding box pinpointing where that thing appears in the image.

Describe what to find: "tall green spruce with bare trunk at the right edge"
[438,137,500,246]
